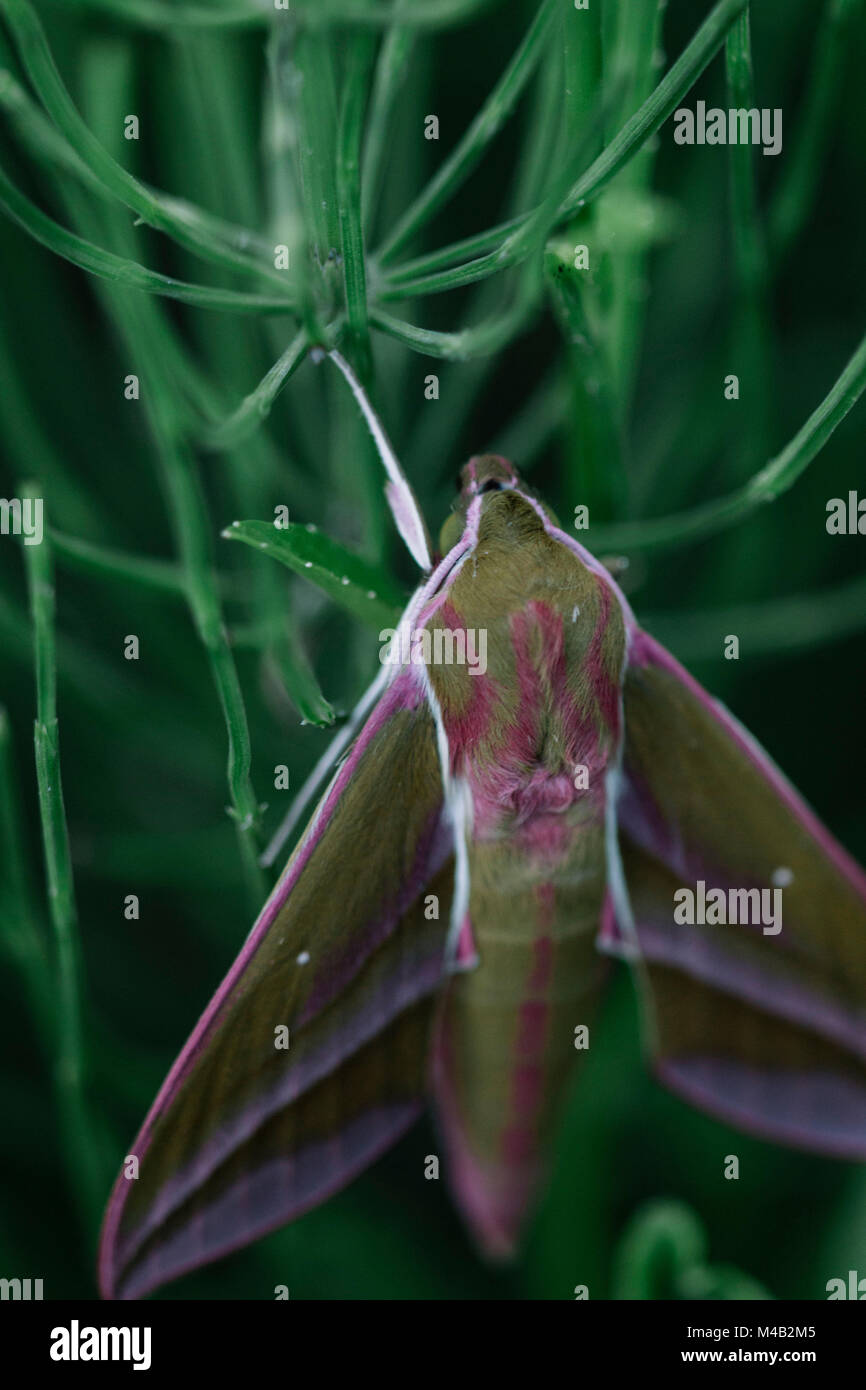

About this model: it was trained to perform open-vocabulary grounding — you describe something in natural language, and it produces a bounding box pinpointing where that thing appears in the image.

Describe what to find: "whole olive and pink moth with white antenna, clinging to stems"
[100,354,866,1298]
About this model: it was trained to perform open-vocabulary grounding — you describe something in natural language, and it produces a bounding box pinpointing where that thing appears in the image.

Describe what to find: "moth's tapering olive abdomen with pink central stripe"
[434,816,605,1255]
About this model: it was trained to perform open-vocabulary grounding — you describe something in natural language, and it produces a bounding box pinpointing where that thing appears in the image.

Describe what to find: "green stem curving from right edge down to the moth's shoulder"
[591,338,866,553]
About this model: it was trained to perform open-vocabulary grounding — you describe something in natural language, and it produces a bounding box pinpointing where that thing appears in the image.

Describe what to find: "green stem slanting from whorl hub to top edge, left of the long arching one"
[377,0,555,265]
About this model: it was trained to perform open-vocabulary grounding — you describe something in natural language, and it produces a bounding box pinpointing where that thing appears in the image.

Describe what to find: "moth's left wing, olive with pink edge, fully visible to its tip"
[100,669,453,1297]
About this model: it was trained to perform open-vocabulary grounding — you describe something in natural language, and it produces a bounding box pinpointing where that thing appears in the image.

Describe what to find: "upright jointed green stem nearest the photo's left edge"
[19,508,100,1225]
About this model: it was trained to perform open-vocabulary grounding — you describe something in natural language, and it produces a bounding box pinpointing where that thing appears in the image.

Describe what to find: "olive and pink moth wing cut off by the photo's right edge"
[606,630,866,1156]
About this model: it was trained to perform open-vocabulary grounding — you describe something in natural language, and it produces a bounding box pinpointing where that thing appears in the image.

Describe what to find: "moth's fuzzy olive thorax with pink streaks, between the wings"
[425,488,626,858]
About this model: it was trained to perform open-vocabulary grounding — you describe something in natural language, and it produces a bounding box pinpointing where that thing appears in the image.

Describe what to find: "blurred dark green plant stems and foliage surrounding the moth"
[0,0,866,1298]
